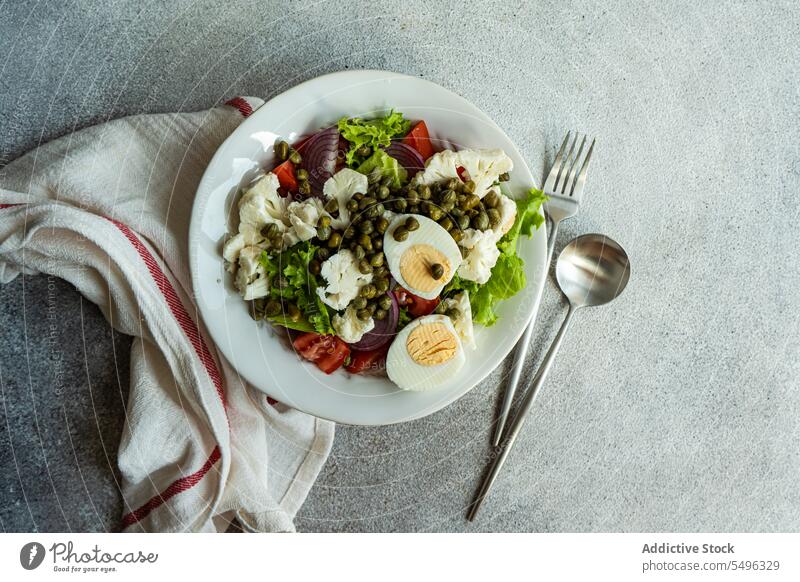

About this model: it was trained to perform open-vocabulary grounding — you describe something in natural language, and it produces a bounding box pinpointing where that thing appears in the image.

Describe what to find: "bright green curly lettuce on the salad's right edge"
[445,188,547,327]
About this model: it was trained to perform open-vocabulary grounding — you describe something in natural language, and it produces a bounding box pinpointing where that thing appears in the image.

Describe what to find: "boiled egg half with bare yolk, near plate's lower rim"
[386,315,466,392]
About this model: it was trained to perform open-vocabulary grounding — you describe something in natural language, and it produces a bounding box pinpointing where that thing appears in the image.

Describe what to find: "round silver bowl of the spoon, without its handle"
[556,234,631,308]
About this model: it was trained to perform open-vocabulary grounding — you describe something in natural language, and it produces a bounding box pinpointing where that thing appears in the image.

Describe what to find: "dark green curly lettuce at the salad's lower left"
[261,241,334,335]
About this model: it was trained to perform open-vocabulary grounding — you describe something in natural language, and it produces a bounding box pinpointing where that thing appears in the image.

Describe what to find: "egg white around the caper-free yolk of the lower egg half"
[386,315,466,392]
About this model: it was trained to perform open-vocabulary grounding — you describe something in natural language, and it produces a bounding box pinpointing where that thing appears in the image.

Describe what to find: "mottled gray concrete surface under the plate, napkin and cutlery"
[0,0,800,531]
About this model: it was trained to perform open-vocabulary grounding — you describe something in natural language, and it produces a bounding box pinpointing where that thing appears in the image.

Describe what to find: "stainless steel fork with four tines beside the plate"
[492,131,595,446]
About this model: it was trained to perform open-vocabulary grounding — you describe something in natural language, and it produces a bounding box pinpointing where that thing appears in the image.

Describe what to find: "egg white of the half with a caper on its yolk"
[383,214,461,299]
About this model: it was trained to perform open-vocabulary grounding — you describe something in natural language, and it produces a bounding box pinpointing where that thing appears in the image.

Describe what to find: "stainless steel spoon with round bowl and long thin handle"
[467,234,631,521]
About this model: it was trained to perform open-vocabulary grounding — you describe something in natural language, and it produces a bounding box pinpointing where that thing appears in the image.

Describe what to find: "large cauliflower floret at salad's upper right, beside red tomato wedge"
[414,149,514,198]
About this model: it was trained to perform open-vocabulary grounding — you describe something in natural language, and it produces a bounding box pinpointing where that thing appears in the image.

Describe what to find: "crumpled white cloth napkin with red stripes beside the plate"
[0,97,334,532]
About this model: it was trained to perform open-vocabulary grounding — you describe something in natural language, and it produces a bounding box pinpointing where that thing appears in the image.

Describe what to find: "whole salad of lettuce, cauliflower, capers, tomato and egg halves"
[222,111,546,391]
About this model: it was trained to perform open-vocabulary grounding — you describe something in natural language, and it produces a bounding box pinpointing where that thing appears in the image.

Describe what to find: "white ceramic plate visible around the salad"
[189,71,546,425]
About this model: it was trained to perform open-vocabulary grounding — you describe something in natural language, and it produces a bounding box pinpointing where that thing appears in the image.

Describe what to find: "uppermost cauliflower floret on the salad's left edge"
[239,172,288,246]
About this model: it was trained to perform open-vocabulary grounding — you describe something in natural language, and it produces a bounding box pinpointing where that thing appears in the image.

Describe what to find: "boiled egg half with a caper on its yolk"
[383,214,461,299]
